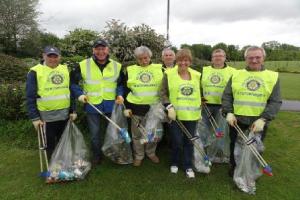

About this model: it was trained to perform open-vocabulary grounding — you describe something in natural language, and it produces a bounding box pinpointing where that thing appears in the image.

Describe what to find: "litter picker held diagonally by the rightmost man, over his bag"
[234,125,273,176]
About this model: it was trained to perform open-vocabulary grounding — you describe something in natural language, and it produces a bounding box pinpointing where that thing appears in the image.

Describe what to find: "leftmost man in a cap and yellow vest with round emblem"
[26,46,77,159]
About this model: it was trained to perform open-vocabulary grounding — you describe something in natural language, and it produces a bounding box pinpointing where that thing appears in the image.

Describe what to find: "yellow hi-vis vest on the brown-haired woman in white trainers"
[166,68,201,120]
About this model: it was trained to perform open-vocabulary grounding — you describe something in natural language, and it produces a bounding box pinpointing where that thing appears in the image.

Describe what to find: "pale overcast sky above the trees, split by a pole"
[38,0,300,47]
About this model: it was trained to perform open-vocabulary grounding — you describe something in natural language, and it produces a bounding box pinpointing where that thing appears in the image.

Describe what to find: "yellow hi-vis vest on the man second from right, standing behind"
[201,66,235,104]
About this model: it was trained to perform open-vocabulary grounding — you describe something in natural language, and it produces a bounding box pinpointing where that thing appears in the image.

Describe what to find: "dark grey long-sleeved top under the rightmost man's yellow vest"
[222,67,282,125]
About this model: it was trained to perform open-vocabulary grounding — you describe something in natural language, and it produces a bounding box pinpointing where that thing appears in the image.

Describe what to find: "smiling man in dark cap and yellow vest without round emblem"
[71,39,124,165]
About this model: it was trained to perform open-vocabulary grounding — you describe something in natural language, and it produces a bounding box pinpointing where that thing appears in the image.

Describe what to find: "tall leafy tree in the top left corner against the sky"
[0,0,39,54]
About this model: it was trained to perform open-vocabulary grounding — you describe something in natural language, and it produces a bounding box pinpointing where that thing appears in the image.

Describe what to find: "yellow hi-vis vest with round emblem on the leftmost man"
[31,64,70,111]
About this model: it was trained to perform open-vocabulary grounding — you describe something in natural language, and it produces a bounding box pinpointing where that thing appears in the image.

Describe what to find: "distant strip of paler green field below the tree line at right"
[228,61,300,72]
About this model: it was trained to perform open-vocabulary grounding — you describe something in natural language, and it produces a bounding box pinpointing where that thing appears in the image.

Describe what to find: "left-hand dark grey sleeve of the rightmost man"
[222,78,233,115]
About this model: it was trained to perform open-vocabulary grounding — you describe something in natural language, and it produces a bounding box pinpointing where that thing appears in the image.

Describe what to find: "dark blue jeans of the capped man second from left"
[86,113,111,160]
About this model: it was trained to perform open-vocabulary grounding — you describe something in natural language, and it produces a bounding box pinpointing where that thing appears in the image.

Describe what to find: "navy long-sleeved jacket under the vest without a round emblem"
[70,55,124,113]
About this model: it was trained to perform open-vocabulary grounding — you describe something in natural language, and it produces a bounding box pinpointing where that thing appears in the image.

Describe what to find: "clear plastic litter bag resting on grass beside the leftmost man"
[47,120,91,183]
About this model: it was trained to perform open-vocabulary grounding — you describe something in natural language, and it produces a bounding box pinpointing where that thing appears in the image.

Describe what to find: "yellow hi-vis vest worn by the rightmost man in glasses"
[232,69,278,116]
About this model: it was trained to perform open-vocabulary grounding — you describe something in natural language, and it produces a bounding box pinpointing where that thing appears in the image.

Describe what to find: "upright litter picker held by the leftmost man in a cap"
[37,125,50,178]
